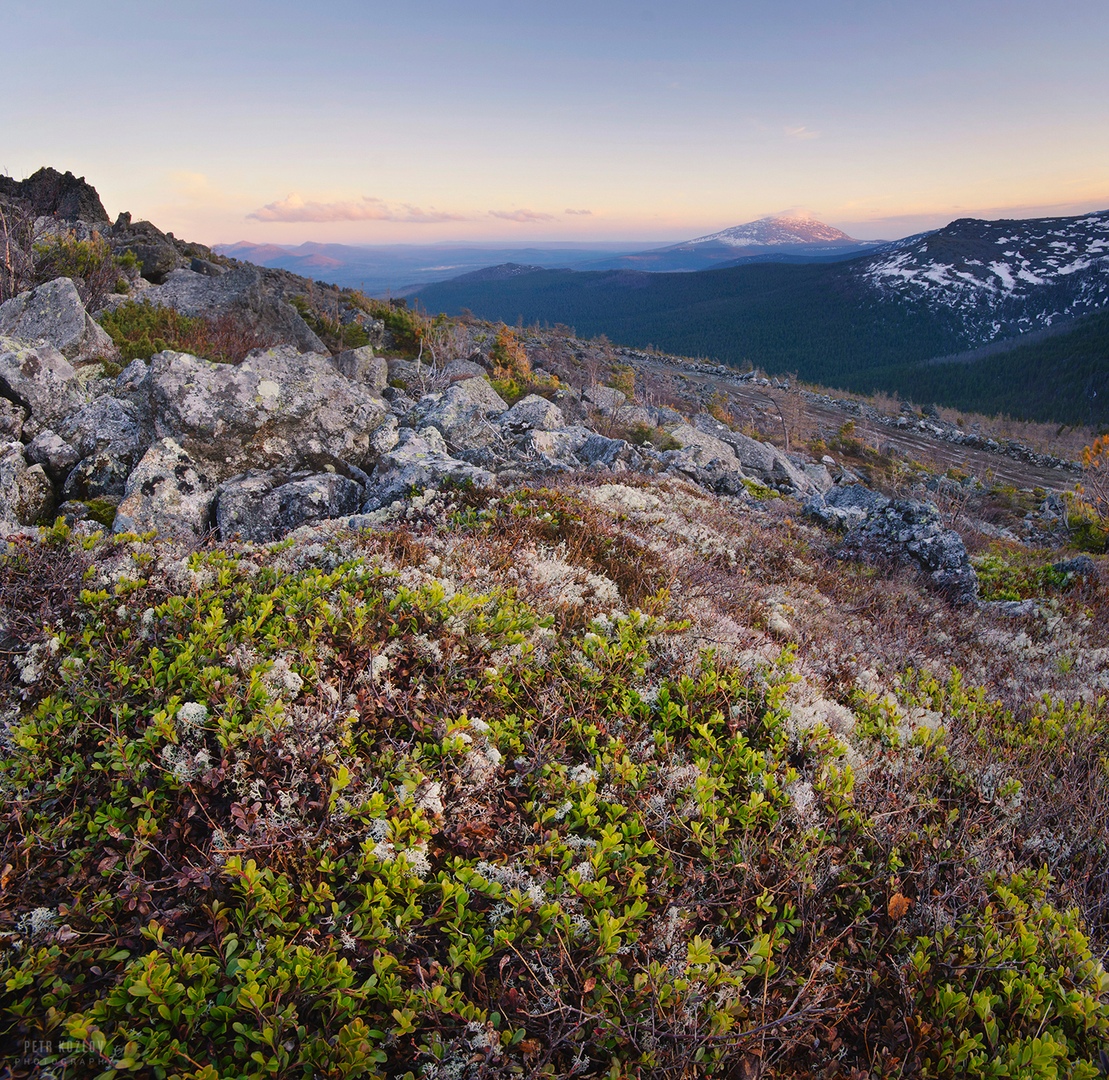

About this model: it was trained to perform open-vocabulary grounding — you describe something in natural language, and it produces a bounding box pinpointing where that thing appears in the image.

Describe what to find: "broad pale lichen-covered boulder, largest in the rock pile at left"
[150,346,386,477]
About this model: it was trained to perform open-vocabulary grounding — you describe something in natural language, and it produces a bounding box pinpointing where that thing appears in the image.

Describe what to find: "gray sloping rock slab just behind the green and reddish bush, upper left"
[143,266,327,354]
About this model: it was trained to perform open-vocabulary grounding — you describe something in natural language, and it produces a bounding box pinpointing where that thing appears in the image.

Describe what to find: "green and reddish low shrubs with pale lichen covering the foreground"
[0,474,1109,1080]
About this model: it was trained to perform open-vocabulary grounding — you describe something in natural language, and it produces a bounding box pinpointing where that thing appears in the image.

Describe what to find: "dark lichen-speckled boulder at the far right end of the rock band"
[838,499,978,603]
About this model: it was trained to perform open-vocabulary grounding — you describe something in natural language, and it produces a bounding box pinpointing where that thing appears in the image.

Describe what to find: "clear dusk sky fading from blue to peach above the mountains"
[0,0,1109,244]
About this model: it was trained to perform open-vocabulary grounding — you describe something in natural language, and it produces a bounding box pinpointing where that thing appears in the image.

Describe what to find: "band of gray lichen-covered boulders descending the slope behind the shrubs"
[0,174,1091,600]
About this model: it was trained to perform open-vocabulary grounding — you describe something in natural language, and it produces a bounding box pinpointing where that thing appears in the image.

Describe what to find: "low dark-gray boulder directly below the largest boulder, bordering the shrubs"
[215,472,365,543]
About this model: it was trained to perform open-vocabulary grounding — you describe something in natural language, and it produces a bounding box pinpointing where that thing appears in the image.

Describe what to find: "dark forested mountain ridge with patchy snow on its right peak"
[417,211,1109,422]
